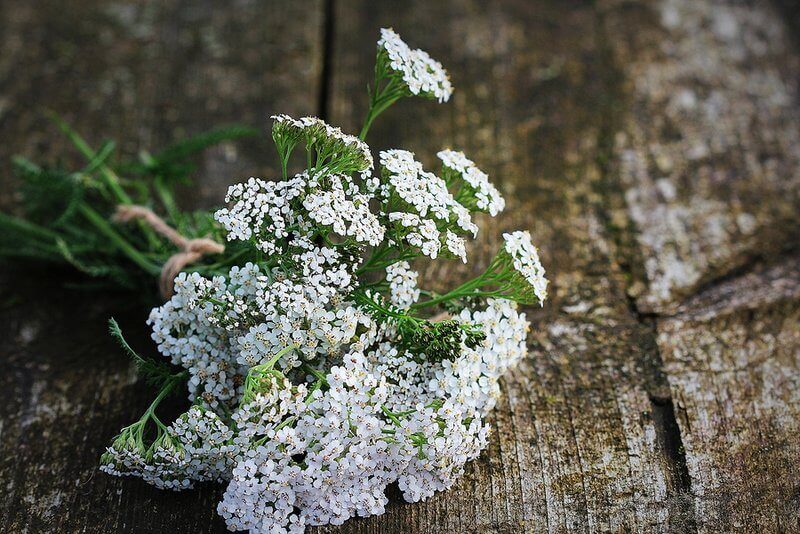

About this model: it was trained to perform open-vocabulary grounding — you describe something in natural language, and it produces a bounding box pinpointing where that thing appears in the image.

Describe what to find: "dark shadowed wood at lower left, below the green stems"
[0,269,228,532]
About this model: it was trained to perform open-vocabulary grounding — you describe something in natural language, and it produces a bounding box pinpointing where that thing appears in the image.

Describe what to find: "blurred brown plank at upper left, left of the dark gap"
[0,0,324,205]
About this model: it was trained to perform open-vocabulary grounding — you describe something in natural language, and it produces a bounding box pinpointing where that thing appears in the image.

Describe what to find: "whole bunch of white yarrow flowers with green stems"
[4,29,547,533]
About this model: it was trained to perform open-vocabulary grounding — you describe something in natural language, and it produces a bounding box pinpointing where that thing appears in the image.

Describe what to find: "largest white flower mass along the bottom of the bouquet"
[142,301,528,532]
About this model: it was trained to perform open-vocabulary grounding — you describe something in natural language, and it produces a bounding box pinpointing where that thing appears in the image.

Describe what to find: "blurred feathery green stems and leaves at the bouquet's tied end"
[0,116,257,295]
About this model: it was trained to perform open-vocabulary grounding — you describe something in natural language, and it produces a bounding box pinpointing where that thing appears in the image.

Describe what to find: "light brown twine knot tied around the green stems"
[113,204,225,299]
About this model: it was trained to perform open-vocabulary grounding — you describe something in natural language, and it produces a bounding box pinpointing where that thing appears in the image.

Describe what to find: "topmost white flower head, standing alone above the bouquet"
[378,28,453,102]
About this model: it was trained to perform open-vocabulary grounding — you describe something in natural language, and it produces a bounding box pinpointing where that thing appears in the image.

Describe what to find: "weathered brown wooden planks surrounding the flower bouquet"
[0,0,800,533]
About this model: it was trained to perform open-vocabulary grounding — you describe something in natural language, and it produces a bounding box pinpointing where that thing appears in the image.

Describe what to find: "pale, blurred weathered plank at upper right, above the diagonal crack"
[614,0,800,313]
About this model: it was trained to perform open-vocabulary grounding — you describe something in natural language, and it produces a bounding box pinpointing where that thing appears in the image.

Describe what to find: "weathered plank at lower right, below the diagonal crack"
[658,256,800,532]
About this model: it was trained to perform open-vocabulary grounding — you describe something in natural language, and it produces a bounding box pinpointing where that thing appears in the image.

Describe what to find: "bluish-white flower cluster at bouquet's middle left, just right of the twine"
[149,255,374,408]
